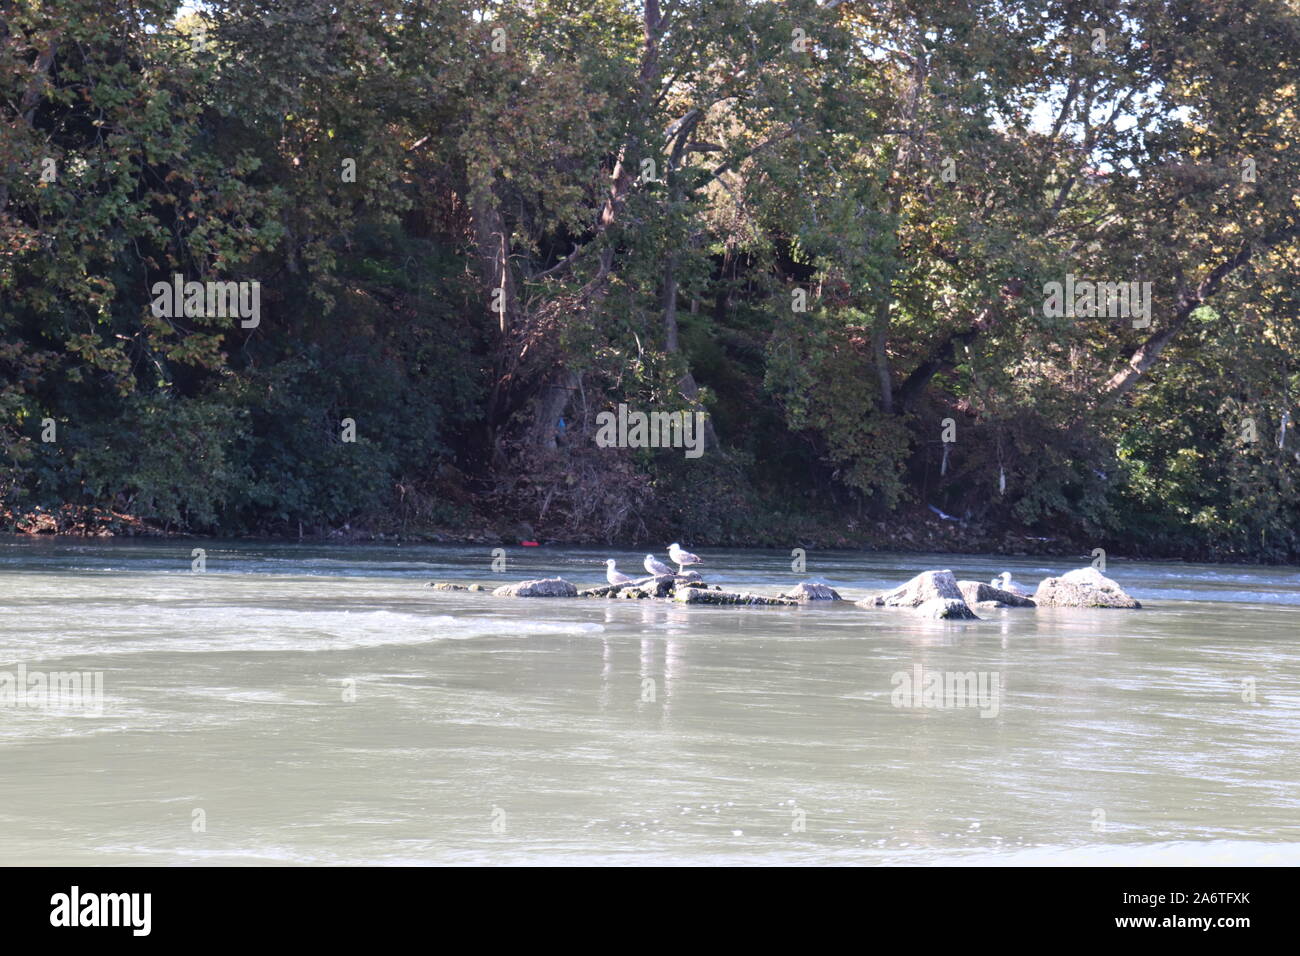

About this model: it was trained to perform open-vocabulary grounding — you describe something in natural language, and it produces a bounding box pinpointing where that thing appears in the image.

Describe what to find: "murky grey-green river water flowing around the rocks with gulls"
[0,538,1300,865]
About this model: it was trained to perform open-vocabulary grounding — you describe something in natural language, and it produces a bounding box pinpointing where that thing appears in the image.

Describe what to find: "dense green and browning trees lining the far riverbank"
[0,0,1300,561]
